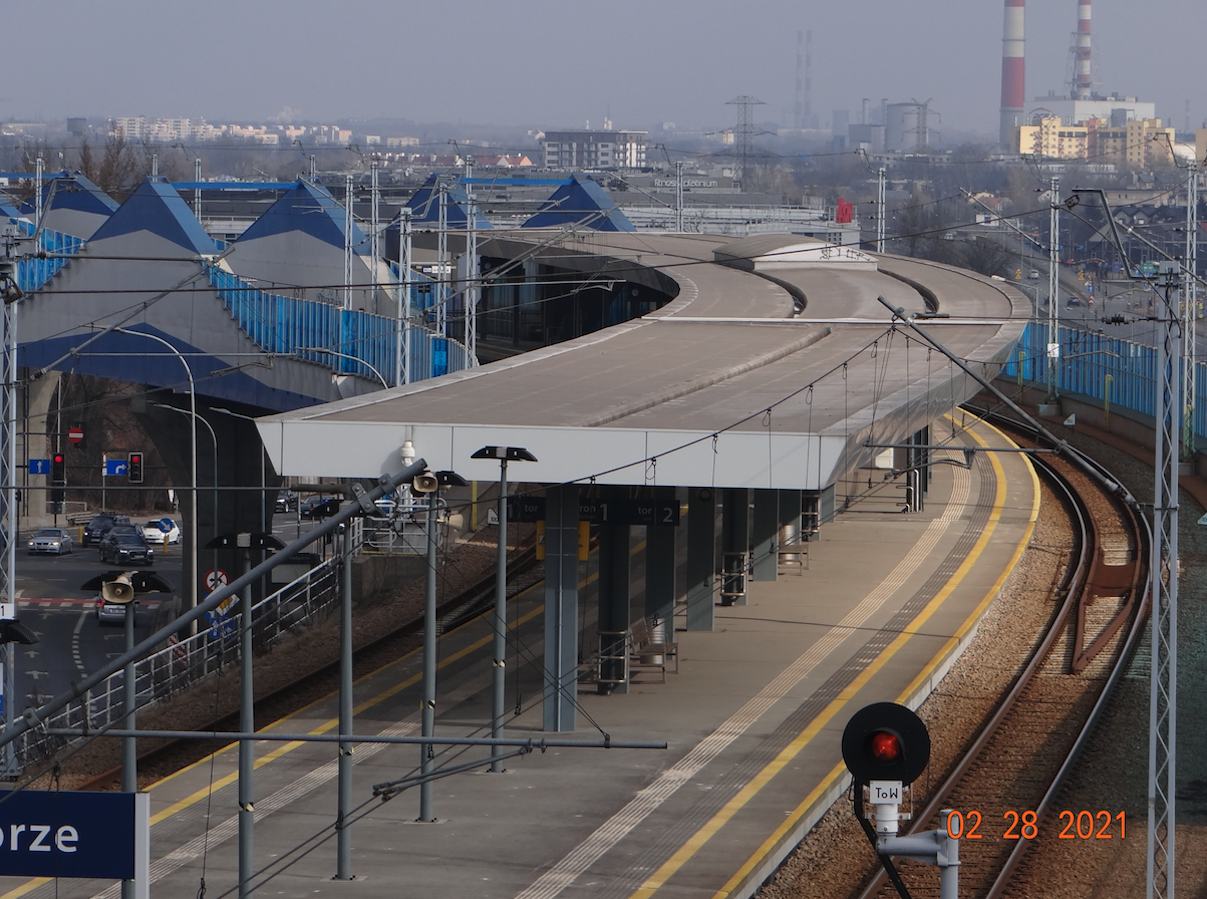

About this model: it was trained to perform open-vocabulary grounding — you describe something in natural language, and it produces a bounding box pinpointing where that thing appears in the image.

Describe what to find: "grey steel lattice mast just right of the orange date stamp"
[1145,263,1183,899]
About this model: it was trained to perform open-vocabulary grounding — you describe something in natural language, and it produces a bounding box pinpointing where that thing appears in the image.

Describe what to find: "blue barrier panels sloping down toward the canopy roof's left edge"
[206,265,477,386]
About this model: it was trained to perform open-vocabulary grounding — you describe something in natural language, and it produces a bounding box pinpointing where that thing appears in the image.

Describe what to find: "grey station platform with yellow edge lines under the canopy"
[0,412,1039,899]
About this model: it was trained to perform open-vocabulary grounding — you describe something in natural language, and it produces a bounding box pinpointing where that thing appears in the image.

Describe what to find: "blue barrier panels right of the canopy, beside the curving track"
[1002,323,1207,437]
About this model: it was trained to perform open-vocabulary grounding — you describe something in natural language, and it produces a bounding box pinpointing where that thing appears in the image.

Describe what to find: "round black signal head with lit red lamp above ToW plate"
[842,702,931,784]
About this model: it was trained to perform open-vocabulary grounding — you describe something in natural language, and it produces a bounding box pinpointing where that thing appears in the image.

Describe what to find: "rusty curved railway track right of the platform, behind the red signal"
[858,420,1150,899]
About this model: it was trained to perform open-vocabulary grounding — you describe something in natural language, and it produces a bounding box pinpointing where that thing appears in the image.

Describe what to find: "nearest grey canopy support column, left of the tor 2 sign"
[543,485,578,732]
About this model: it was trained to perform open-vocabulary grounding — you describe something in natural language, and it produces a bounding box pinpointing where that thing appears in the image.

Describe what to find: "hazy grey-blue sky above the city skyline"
[7,0,1207,136]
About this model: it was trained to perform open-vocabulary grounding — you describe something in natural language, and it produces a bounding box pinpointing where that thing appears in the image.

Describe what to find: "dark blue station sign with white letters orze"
[0,790,151,880]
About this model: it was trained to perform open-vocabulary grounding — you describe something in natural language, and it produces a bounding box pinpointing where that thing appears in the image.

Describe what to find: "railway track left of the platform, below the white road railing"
[76,547,543,790]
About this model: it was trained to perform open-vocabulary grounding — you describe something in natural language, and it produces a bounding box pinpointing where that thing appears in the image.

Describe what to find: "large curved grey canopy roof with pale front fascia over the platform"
[258,232,1030,490]
